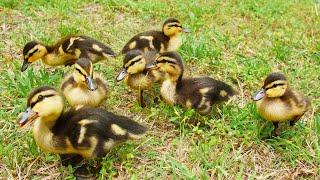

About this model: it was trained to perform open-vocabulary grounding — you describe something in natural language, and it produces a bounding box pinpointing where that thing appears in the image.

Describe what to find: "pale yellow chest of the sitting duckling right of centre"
[160,80,176,104]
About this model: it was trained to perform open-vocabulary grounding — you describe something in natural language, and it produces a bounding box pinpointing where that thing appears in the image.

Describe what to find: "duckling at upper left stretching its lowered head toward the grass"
[21,36,116,72]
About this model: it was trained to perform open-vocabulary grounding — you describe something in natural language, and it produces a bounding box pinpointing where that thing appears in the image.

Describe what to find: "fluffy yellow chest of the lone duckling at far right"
[256,98,296,122]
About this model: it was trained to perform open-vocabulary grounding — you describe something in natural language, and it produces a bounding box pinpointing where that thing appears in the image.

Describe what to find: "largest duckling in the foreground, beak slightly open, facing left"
[18,86,146,158]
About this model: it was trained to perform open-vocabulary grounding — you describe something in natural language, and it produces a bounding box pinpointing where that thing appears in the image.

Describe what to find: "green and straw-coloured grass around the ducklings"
[0,0,320,179]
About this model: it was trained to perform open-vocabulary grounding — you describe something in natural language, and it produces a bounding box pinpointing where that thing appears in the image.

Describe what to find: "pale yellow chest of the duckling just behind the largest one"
[63,86,107,106]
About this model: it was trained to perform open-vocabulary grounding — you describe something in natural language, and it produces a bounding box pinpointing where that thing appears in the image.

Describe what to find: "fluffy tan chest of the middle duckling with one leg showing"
[125,73,154,90]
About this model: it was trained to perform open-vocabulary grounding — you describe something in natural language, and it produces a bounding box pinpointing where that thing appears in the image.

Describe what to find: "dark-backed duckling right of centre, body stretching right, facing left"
[150,52,236,115]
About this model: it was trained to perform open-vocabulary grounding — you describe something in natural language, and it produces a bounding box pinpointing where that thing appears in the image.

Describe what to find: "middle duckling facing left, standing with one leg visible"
[116,50,163,107]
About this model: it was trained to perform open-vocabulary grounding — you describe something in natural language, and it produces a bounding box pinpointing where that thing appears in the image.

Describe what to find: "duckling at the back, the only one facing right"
[121,18,191,54]
